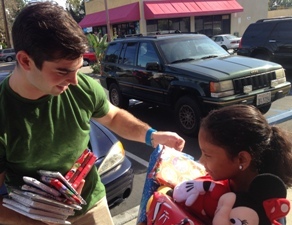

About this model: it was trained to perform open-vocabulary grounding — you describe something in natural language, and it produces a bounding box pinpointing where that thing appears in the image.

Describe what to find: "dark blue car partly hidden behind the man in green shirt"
[0,120,134,208]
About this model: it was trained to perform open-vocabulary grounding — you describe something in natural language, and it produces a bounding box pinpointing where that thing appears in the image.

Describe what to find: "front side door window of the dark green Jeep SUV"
[137,42,159,68]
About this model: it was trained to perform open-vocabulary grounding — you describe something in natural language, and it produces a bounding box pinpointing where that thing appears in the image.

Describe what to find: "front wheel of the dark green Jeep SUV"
[175,96,201,135]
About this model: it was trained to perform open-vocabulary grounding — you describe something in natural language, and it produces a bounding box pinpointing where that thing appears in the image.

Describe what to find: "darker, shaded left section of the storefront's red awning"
[79,2,140,28]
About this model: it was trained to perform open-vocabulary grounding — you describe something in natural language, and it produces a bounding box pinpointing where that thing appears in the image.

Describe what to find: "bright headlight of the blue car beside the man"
[98,141,125,175]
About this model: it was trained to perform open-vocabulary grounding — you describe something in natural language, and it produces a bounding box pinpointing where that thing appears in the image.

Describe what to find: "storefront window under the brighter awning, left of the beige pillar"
[146,17,190,34]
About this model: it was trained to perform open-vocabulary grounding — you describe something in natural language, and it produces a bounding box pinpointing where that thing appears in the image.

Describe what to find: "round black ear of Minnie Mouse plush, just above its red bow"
[249,173,287,202]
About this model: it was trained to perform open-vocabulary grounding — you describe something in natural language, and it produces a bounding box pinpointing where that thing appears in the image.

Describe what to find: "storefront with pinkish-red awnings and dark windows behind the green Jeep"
[79,0,243,37]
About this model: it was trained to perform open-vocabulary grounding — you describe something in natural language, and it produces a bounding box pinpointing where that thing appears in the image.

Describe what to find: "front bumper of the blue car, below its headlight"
[101,157,134,208]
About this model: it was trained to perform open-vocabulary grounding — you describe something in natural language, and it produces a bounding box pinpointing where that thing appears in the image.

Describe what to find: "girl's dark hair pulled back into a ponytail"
[201,105,292,187]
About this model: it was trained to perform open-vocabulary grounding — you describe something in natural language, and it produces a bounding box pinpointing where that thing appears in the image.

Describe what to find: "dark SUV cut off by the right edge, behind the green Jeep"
[237,17,292,69]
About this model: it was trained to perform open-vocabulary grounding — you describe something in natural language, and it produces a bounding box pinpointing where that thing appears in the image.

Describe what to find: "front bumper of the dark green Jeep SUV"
[203,82,291,110]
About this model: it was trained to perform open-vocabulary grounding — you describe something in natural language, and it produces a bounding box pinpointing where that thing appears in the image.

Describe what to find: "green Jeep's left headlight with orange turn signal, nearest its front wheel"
[210,80,234,98]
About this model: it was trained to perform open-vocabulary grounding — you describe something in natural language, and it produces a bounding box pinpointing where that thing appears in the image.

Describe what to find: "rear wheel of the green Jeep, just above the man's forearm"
[108,83,129,109]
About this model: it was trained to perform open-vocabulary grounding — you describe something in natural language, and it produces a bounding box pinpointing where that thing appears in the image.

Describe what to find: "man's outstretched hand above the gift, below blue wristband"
[152,131,185,151]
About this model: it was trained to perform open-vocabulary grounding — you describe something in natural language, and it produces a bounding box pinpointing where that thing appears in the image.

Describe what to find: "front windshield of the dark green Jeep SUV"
[159,36,229,63]
